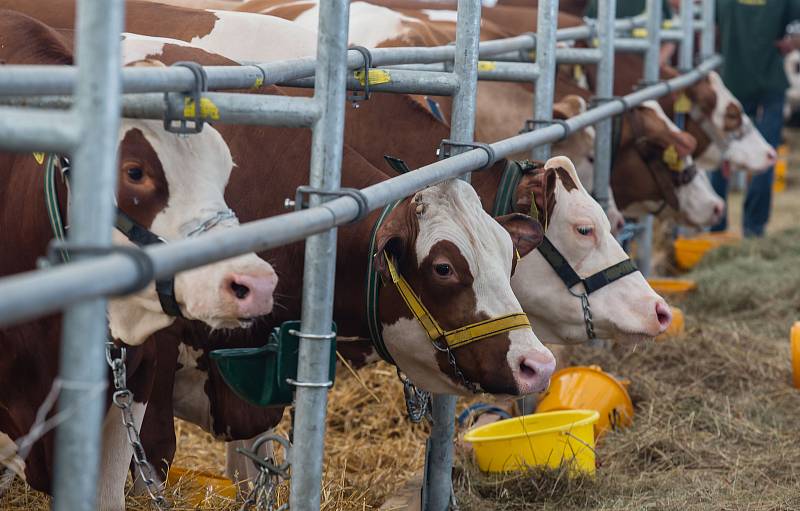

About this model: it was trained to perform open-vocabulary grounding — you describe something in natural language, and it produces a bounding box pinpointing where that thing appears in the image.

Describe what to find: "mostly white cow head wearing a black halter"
[511,157,671,343]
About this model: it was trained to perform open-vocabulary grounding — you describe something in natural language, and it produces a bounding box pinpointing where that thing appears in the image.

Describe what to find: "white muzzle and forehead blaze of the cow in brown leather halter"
[642,101,724,227]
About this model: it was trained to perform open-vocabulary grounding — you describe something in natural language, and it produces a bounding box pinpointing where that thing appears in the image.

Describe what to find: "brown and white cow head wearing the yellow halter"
[374,180,555,395]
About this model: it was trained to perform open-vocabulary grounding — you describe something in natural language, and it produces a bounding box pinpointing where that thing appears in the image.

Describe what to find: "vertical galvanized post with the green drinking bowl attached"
[289,0,350,511]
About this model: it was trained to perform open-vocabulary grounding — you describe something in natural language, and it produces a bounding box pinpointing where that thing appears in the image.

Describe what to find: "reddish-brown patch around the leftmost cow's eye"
[117,128,169,227]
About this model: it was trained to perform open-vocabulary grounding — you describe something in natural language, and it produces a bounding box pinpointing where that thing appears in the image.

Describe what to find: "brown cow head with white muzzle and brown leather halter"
[611,101,725,227]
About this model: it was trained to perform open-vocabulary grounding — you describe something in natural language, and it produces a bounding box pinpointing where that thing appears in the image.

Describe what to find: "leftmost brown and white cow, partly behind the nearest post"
[0,11,277,506]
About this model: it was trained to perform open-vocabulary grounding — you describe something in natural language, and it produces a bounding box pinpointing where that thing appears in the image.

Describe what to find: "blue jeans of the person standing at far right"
[711,93,784,237]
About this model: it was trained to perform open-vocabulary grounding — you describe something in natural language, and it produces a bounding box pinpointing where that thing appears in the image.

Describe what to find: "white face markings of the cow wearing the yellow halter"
[383,180,555,394]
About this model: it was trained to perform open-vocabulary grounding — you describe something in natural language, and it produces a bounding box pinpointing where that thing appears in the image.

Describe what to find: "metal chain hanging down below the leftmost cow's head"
[106,341,170,510]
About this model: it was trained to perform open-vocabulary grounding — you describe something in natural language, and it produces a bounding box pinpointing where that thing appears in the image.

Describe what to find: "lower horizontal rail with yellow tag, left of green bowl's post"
[0,92,319,128]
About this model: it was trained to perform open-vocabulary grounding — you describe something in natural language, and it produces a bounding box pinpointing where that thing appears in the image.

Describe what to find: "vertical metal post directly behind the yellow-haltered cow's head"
[422,0,481,511]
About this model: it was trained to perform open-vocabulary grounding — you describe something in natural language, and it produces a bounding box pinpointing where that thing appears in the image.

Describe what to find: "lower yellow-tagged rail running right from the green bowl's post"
[283,69,458,96]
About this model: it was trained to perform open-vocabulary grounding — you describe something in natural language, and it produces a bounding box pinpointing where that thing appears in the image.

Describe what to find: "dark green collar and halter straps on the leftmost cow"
[42,154,183,318]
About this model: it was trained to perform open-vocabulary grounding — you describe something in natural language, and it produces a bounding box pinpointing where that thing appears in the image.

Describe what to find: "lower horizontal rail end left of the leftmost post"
[0,107,80,154]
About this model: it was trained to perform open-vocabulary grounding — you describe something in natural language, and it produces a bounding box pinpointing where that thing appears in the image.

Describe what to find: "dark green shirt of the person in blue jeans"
[717,0,800,100]
